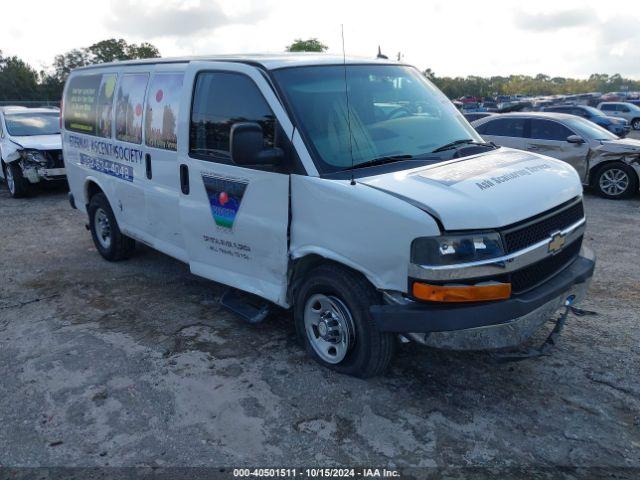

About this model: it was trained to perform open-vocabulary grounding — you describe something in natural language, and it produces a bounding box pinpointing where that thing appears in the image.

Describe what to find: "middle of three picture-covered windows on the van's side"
[116,73,149,143]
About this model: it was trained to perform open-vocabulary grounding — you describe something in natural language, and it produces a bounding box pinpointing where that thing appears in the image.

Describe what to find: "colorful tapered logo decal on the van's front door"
[202,175,247,229]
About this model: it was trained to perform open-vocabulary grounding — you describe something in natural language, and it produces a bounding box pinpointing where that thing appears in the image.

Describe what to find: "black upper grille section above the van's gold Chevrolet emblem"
[502,201,584,253]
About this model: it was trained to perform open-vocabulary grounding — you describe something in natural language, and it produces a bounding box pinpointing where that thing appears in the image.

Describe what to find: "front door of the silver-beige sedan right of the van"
[526,118,589,180]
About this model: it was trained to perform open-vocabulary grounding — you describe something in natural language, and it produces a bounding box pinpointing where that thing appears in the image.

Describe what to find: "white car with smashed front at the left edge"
[0,107,66,198]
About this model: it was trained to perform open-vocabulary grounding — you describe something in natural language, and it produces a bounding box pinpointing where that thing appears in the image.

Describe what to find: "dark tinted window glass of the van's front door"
[189,72,276,161]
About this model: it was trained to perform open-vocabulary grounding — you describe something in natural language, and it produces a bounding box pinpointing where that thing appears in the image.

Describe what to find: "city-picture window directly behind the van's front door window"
[144,73,184,151]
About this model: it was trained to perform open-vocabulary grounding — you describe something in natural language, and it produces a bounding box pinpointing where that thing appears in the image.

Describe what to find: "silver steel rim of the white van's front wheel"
[304,294,355,364]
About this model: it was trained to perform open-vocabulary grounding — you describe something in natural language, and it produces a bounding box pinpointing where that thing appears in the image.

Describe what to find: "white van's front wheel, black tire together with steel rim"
[294,265,396,378]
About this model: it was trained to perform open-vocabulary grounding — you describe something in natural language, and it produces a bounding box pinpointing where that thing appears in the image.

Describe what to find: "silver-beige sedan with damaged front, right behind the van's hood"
[472,112,640,199]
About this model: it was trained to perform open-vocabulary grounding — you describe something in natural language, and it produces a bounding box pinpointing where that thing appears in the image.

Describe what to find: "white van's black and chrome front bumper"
[371,248,595,350]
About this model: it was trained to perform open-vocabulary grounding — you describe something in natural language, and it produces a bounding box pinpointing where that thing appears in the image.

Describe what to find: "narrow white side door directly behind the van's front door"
[144,64,188,262]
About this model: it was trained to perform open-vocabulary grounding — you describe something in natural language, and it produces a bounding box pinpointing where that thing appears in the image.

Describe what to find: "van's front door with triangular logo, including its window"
[178,62,292,306]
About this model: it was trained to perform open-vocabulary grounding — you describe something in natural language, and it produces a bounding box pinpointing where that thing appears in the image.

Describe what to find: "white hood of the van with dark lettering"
[359,148,582,230]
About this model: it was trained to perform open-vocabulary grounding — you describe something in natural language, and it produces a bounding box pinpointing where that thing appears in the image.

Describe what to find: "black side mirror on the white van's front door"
[229,122,284,166]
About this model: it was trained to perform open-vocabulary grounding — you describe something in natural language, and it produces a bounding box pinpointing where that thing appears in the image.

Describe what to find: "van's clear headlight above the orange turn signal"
[411,232,504,265]
